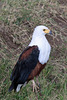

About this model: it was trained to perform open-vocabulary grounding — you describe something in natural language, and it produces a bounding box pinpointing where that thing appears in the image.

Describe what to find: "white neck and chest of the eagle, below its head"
[29,37,51,64]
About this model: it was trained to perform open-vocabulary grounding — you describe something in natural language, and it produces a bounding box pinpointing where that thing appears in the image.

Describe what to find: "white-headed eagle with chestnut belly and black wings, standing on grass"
[9,25,52,92]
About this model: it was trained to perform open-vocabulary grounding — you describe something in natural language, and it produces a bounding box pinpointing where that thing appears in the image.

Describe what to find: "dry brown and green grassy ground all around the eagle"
[0,0,67,100]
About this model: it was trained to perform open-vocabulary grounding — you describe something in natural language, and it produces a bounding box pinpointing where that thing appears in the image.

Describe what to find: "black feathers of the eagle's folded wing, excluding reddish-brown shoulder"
[9,47,39,91]
